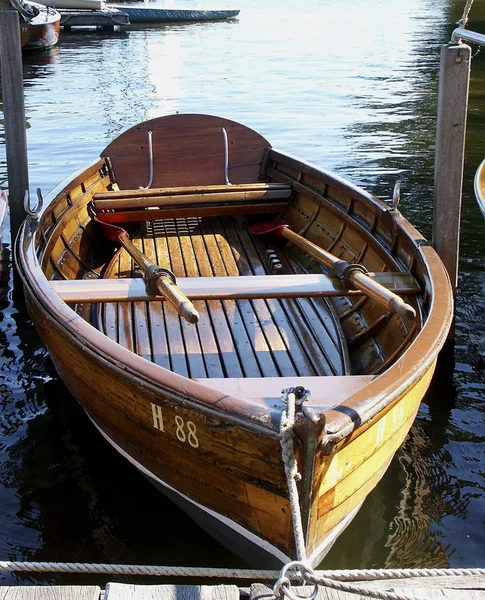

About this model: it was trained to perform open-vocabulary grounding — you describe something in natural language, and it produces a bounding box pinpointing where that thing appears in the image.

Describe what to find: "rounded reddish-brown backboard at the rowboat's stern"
[102,115,270,189]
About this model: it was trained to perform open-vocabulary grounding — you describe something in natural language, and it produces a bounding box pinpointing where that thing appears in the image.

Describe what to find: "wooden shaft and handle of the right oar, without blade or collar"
[279,227,416,319]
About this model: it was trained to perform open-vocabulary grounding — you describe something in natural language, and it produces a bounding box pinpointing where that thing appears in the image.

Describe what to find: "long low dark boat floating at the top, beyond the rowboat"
[106,3,240,23]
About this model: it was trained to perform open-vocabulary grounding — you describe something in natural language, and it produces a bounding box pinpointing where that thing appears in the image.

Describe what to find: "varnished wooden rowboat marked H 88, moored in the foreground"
[16,115,452,565]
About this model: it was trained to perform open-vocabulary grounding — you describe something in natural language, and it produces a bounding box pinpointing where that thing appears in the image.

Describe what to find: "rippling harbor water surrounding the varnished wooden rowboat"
[0,0,485,585]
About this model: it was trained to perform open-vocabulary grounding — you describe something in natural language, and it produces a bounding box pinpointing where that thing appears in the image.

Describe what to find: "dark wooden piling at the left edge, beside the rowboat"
[0,10,29,240]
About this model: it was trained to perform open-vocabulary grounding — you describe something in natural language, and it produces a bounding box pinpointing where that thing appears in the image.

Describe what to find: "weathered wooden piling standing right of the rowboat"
[433,43,471,339]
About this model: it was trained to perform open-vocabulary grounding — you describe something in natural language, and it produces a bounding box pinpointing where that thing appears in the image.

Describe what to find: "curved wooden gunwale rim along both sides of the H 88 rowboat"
[16,153,453,442]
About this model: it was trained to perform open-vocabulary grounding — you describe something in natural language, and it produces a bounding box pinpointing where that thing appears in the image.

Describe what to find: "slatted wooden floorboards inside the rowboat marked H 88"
[98,217,346,378]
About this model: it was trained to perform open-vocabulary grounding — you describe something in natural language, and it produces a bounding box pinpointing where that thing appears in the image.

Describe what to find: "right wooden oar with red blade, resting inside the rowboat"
[249,220,416,319]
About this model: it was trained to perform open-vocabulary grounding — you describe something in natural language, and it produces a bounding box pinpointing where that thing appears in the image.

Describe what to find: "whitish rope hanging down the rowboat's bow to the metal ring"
[280,388,306,562]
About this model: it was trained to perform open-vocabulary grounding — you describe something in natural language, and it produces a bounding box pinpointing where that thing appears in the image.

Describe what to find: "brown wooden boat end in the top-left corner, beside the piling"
[7,0,61,51]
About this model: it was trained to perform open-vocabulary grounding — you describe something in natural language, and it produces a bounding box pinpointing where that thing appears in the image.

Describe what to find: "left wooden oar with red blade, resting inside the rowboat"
[91,214,199,323]
